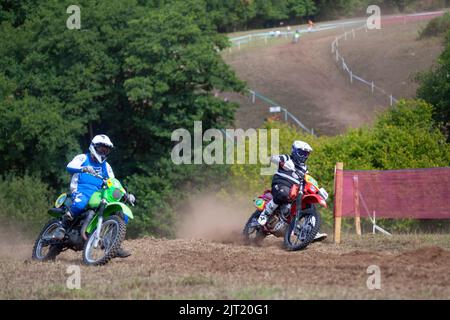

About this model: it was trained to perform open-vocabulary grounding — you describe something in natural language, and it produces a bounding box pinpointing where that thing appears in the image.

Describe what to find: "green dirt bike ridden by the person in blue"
[32,174,134,266]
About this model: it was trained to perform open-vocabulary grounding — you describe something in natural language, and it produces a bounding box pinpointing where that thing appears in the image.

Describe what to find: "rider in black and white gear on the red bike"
[258,141,327,241]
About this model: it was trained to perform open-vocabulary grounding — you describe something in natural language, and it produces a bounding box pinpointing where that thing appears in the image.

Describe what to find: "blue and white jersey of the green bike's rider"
[67,153,114,193]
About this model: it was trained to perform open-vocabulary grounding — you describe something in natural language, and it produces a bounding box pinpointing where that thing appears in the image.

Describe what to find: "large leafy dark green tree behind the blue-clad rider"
[0,0,243,183]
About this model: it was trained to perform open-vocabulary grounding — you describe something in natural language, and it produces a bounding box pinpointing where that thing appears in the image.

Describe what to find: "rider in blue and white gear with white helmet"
[57,134,136,258]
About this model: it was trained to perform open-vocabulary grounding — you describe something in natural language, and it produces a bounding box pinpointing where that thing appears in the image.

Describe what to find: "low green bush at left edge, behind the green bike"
[0,175,57,236]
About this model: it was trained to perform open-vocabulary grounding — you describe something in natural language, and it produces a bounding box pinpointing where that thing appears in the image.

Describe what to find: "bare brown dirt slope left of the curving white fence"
[227,28,377,135]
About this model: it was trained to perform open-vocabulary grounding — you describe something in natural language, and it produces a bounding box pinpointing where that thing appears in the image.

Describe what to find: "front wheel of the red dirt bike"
[284,206,321,251]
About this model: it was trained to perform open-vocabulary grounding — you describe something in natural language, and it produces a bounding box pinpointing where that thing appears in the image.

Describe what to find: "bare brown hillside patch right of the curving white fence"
[340,22,443,98]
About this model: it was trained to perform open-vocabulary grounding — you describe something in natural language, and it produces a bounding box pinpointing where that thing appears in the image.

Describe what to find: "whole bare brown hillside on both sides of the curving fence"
[224,22,442,135]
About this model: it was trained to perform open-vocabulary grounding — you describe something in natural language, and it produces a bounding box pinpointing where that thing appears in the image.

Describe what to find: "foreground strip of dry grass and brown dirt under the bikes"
[0,234,450,299]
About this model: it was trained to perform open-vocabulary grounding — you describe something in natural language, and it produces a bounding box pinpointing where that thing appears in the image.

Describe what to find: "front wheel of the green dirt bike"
[83,215,126,266]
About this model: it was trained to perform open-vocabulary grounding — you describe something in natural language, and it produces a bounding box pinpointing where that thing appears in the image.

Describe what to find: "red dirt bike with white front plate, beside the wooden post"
[243,174,328,251]
